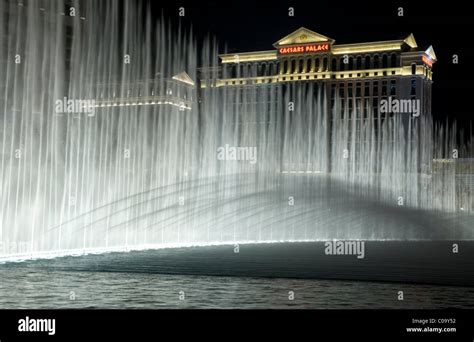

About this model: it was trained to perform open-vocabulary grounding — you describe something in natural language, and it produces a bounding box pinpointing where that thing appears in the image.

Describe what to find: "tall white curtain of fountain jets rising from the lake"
[0,0,474,259]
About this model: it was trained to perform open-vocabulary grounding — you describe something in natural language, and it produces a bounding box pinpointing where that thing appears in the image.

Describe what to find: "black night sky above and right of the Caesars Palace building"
[152,0,474,132]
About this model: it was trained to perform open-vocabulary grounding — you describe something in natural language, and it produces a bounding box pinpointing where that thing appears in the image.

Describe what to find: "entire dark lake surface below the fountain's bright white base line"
[0,242,474,309]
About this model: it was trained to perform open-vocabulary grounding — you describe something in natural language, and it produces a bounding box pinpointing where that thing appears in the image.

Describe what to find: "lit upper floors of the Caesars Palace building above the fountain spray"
[207,27,436,119]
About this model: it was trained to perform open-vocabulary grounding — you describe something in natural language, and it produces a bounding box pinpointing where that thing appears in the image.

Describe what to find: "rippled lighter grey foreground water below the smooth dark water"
[0,267,474,309]
